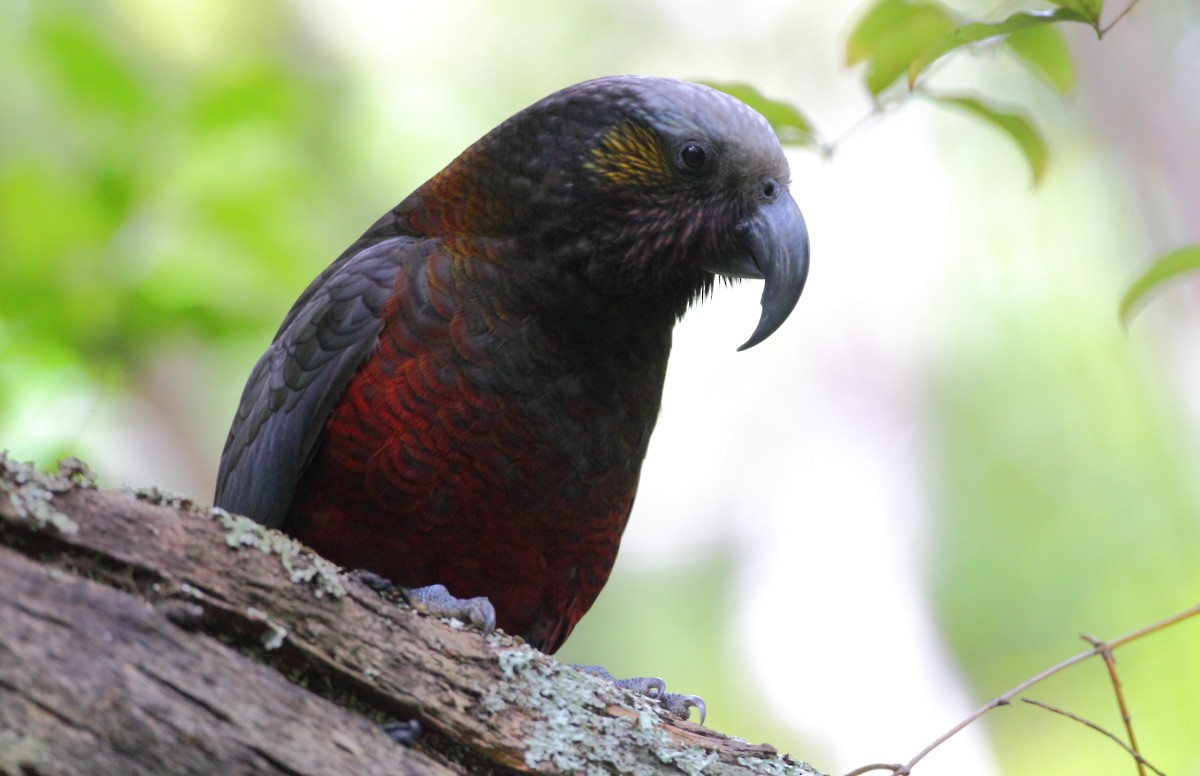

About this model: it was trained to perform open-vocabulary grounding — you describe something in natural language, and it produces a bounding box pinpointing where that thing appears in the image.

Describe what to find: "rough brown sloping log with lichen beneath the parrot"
[0,453,815,775]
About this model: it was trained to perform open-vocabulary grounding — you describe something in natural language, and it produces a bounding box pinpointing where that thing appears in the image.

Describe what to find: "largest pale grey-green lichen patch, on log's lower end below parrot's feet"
[481,646,716,776]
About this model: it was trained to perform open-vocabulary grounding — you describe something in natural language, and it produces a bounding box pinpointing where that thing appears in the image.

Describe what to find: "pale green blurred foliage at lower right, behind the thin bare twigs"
[931,274,1200,774]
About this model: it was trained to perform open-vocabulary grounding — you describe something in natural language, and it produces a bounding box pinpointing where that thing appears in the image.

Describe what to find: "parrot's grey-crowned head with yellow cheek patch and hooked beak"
[431,76,809,349]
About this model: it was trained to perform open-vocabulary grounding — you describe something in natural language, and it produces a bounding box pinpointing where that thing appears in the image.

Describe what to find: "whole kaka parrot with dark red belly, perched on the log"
[215,77,809,652]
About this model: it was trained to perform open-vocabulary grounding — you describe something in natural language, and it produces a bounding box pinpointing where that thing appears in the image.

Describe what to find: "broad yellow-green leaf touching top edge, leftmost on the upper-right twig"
[846,0,954,95]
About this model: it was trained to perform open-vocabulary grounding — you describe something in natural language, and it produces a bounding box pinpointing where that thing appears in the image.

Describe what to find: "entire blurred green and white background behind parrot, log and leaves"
[0,0,1200,776]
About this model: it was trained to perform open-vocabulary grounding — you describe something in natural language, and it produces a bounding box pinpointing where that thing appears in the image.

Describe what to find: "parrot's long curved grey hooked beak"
[704,191,809,350]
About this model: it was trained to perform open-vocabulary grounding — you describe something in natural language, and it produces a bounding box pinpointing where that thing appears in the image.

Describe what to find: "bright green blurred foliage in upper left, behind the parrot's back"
[0,2,355,463]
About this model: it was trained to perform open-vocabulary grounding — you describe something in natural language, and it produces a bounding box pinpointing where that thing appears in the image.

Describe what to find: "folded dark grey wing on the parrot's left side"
[215,237,415,528]
